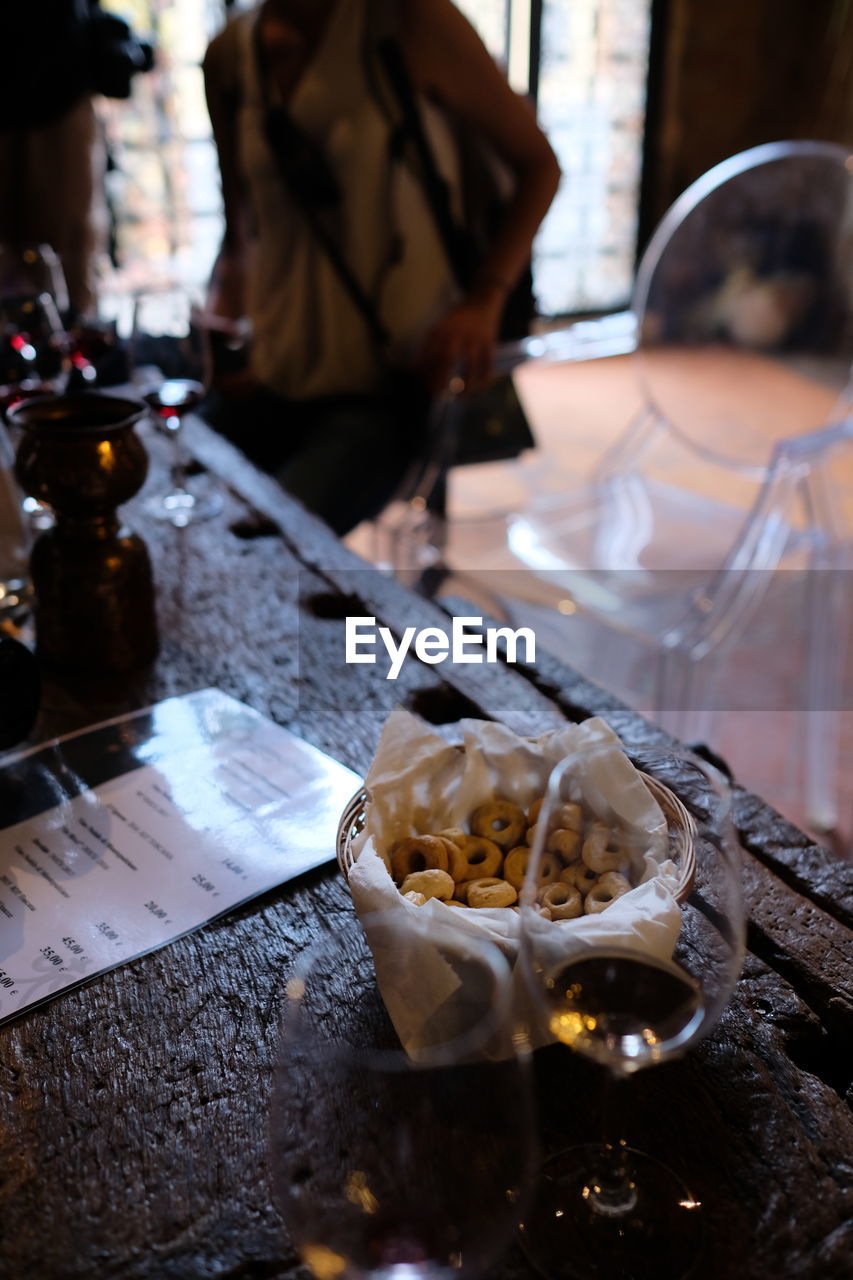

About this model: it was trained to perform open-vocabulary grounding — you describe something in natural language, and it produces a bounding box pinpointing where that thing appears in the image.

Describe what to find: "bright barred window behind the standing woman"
[102,0,652,316]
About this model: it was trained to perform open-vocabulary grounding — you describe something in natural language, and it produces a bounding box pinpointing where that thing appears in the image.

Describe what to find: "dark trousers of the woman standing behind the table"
[202,380,428,535]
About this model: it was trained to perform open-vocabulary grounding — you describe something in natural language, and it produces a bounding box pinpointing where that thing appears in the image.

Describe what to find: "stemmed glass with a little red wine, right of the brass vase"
[129,288,223,529]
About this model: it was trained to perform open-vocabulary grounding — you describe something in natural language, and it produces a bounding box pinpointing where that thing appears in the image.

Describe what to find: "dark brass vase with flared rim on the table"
[9,392,158,675]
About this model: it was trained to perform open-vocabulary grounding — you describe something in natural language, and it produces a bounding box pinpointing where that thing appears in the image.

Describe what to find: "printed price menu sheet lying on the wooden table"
[0,689,360,1023]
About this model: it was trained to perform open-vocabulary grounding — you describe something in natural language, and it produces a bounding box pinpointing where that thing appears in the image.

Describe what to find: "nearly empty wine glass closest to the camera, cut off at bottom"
[270,905,538,1280]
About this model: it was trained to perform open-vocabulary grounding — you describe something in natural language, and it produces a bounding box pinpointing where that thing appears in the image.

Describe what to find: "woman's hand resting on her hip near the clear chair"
[415,284,506,393]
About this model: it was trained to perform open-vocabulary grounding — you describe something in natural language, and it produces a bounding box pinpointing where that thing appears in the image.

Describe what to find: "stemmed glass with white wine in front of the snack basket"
[519,744,744,1280]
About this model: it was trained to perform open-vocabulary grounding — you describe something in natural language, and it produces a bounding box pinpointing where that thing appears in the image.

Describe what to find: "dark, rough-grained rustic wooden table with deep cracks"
[0,422,853,1280]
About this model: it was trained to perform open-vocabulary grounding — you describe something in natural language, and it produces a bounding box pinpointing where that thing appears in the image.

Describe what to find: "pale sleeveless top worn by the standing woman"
[225,0,459,398]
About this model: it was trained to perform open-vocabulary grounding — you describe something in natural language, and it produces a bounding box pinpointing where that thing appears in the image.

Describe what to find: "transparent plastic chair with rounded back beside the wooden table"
[425,142,853,829]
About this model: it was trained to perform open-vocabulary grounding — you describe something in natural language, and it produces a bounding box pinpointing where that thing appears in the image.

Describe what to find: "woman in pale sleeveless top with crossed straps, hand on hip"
[204,0,560,532]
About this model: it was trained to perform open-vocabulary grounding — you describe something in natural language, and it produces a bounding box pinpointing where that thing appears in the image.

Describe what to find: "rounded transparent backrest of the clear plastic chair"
[633,141,853,470]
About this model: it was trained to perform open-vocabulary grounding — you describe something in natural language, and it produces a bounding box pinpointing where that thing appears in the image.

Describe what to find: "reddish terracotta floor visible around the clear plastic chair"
[352,357,853,856]
